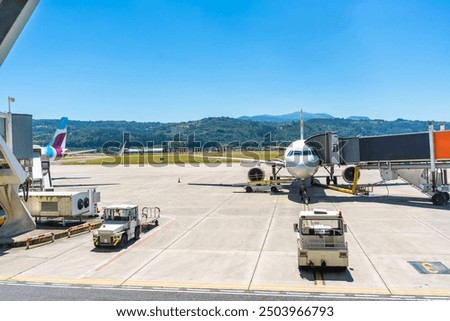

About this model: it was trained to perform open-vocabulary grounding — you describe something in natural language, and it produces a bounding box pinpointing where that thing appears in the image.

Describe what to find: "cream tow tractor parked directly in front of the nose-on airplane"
[294,209,348,268]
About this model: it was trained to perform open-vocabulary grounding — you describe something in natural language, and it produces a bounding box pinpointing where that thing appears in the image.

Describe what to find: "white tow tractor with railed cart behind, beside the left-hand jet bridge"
[93,204,160,247]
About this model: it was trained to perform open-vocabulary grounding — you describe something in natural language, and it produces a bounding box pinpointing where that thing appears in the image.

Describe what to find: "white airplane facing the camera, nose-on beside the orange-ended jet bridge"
[216,111,321,202]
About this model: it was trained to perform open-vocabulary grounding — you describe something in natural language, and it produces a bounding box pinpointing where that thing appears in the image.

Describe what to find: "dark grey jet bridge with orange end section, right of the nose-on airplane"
[306,122,450,205]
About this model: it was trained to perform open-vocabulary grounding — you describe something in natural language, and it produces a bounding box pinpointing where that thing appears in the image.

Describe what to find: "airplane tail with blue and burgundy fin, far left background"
[33,117,96,161]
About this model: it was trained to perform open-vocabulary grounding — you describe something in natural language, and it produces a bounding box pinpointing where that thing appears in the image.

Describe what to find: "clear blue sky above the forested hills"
[0,0,450,122]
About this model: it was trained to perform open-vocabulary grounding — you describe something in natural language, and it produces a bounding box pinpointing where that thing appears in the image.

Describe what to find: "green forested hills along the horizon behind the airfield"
[33,117,450,149]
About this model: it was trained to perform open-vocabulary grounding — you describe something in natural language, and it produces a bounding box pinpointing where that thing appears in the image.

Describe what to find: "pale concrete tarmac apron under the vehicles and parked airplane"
[0,164,450,298]
